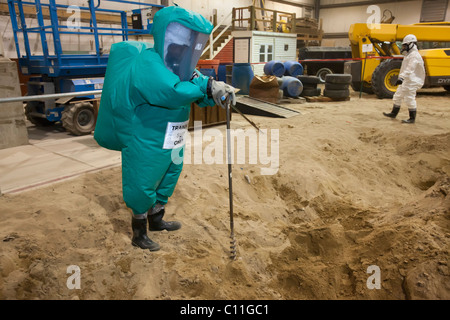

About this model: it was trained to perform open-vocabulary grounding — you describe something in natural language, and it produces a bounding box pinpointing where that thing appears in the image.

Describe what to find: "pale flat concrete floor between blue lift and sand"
[0,124,121,194]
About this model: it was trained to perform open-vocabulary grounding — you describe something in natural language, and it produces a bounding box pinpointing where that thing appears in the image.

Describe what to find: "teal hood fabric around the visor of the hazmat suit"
[151,6,213,57]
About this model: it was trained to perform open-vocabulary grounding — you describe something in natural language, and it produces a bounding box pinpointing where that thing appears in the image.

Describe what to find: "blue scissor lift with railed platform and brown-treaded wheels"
[8,0,163,135]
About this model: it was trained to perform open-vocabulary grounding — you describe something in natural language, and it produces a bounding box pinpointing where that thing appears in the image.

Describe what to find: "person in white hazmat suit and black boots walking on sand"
[383,34,425,123]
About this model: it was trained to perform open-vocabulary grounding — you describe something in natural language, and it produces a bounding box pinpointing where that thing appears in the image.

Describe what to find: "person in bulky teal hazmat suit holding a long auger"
[94,6,236,251]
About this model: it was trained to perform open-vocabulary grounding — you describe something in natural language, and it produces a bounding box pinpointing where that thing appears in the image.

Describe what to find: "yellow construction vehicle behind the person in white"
[344,22,450,98]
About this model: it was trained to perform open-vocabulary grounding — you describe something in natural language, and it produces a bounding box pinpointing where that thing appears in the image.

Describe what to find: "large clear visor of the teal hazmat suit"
[164,22,209,81]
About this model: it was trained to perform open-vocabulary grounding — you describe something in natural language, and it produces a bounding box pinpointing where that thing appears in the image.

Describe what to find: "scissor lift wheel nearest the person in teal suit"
[61,102,96,136]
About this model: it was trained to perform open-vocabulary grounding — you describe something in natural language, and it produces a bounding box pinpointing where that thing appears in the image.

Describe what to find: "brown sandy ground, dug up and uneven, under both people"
[0,85,450,300]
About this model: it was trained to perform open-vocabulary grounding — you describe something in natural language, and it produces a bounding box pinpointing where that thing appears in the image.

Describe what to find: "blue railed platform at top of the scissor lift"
[8,0,163,77]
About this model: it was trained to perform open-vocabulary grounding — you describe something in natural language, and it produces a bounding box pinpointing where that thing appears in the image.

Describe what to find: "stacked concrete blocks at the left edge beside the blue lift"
[0,57,28,149]
